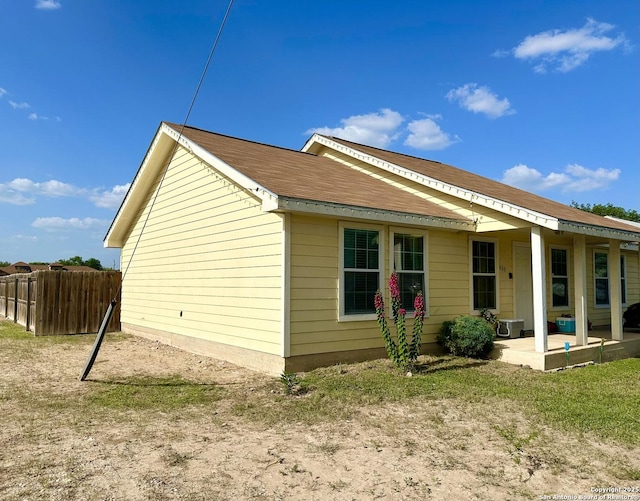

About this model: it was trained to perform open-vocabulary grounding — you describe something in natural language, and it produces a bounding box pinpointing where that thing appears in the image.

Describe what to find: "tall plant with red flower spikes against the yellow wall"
[374,271,424,370]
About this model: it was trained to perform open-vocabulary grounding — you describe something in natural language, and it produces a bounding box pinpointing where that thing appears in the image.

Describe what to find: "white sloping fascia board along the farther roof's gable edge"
[302,134,558,230]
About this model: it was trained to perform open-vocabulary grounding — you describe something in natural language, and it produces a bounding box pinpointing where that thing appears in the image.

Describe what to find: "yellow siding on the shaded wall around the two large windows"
[291,215,480,356]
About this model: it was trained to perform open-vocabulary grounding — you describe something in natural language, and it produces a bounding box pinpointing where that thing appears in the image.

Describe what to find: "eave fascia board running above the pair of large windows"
[277,197,475,231]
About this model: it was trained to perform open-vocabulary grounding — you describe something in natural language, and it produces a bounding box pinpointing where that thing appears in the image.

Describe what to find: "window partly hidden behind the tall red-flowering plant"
[392,232,426,311]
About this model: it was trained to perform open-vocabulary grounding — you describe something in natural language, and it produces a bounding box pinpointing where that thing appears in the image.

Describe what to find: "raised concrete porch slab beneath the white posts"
[489,327,640,371]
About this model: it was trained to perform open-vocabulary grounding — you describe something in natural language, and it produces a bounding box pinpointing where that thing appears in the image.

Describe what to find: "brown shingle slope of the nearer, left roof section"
[167,123,468,221]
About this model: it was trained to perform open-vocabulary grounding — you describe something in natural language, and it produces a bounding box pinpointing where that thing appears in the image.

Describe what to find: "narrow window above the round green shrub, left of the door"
[471,240,498,310]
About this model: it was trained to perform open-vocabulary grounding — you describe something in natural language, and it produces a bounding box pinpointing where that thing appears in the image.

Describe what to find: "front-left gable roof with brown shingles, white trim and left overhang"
[105,123,471,247]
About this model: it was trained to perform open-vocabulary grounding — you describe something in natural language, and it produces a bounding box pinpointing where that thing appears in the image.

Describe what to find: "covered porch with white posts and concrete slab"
[493,221,640,370]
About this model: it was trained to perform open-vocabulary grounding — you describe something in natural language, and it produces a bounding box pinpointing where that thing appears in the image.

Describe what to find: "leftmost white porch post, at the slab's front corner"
[531,226,548,353]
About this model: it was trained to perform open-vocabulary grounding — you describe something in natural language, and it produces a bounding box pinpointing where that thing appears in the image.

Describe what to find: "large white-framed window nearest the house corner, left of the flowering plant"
[340,225,382,318]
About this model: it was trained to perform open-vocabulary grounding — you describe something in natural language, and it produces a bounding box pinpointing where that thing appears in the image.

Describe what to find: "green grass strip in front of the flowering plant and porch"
[234,357,640,445]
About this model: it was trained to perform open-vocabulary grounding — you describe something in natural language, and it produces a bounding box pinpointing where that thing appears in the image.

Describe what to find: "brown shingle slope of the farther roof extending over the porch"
[330,137,638,232]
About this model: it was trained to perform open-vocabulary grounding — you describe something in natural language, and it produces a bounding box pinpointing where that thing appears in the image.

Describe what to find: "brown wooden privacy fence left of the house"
[0,271,122,336]
